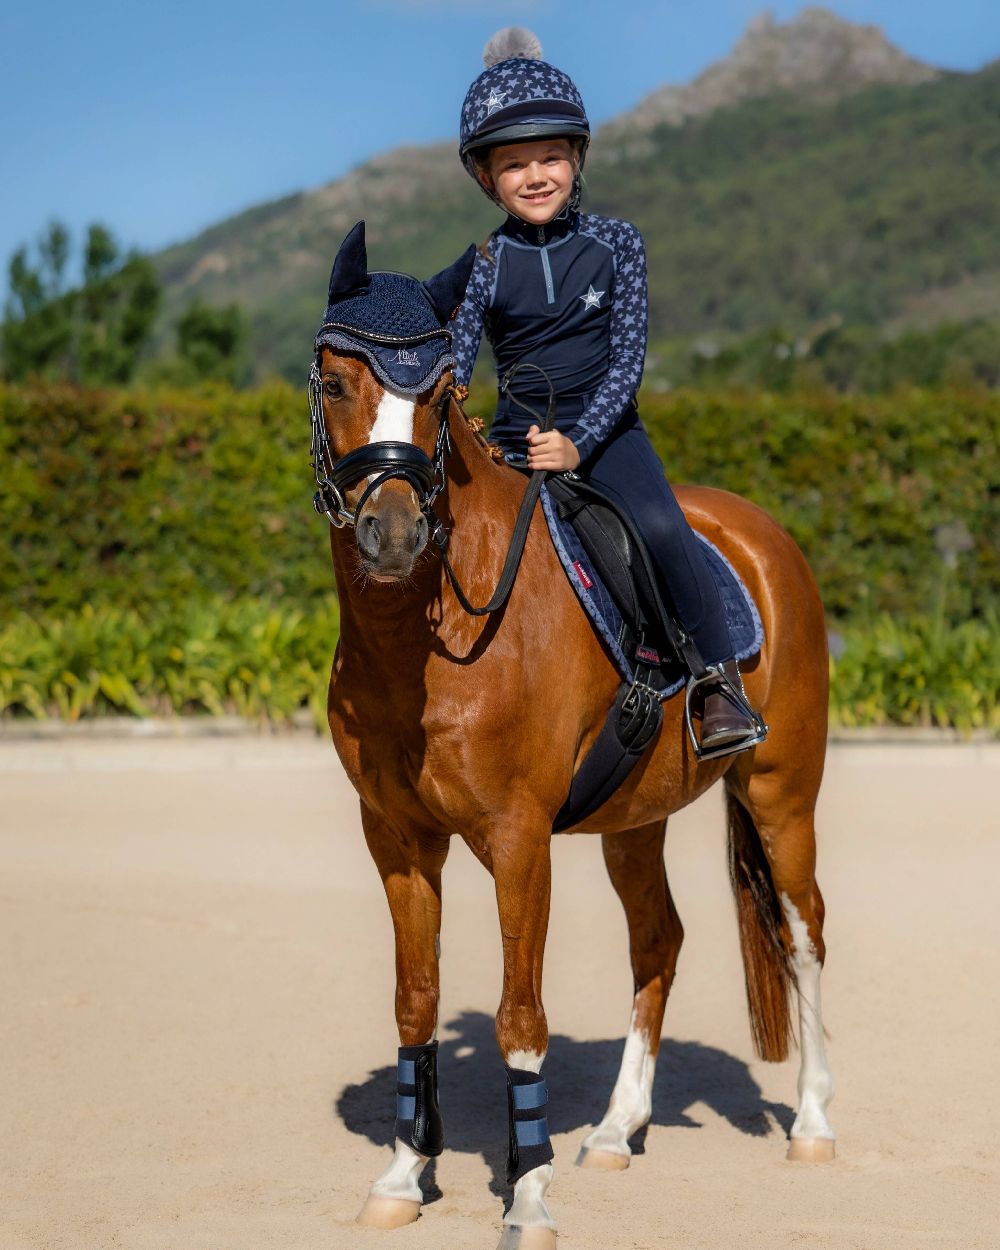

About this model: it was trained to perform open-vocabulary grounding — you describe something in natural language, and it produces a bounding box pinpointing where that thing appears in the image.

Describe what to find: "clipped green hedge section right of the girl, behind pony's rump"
[643,391,1000,620]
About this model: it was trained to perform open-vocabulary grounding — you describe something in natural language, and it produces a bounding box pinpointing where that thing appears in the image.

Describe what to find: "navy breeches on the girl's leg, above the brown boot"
[579,410,733,664]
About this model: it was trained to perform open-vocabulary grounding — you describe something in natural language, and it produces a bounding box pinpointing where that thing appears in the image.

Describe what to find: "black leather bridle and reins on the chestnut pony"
[309,360,555,616]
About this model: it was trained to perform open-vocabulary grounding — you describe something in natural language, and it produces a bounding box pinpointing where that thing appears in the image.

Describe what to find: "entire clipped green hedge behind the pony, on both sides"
[0,375,1000,619]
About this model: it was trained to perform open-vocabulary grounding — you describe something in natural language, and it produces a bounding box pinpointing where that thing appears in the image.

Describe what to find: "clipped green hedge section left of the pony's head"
[0,384,333,613]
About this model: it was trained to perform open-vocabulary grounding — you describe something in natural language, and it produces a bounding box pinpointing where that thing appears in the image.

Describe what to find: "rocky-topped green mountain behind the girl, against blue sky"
[156,9,1000,376]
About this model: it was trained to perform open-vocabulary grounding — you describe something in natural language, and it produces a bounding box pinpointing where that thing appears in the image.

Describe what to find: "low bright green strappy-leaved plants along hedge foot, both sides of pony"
[0,596,1000,731]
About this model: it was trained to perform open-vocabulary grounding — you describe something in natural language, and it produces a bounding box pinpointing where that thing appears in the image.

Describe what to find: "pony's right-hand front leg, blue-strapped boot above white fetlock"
[491,823,556,1250]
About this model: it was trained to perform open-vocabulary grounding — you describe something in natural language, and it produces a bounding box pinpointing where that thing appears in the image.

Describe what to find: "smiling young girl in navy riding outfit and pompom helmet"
[454,28,760,758]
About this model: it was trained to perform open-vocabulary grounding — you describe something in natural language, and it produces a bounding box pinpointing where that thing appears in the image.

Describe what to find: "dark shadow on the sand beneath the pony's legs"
[334,1011,795,1203]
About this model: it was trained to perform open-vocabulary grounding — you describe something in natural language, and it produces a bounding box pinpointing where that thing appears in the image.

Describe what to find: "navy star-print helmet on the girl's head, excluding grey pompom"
[459,56,590,176]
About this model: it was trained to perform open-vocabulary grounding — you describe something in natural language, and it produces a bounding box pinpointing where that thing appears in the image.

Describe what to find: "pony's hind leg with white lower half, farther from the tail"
[576,821,684,1170]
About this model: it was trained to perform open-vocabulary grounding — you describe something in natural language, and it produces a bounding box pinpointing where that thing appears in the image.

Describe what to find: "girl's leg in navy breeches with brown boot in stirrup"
[583,414,758,751]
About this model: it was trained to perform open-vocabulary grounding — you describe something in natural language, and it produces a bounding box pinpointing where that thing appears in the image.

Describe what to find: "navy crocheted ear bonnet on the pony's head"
[314,221,476,395]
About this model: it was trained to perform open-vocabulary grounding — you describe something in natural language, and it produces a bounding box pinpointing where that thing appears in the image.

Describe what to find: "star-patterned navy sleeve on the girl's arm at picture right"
[569,218,649,460]
